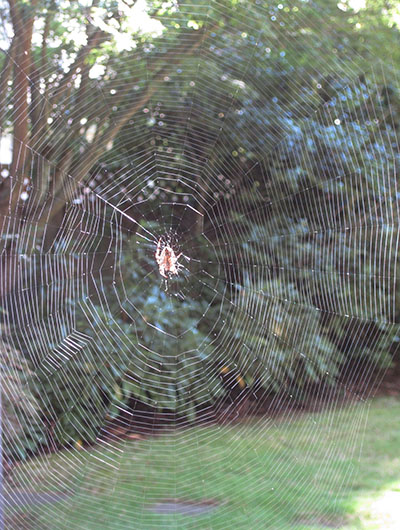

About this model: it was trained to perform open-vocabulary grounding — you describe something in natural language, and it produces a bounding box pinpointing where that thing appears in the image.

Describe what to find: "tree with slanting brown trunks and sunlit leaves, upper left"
[0,0,217,268]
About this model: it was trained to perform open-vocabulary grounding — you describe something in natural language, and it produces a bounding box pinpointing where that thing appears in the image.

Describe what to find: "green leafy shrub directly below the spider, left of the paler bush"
[27,233,224,444]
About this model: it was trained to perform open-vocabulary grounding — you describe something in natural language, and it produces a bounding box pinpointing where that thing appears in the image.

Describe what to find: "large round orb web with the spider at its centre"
[1,2,399,528]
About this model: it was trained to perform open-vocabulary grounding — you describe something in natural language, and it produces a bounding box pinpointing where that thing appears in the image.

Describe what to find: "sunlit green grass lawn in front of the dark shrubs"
[5,398,400,530]
